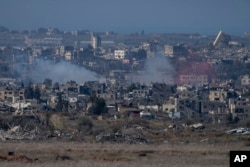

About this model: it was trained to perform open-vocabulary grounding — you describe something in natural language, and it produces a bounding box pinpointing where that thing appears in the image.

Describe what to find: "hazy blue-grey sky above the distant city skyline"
[0,0,250,35]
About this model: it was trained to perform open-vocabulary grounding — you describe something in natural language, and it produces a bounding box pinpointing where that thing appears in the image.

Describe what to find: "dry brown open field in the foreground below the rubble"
[0,141,250,167]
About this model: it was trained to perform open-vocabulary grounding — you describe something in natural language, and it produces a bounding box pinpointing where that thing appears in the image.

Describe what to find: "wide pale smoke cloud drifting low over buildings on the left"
[30,59,98,83]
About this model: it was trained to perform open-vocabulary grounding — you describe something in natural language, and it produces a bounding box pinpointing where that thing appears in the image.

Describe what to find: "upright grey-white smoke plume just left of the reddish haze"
[132,53,174,85]
